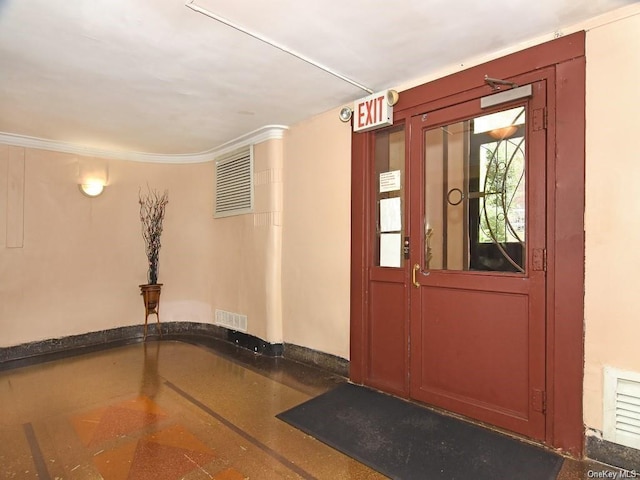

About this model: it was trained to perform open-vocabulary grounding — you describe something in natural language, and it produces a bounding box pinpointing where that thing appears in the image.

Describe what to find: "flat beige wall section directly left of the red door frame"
[282,110,351,358]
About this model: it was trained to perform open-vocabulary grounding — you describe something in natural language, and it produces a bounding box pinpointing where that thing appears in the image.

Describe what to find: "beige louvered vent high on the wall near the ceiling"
[215,147,253,217]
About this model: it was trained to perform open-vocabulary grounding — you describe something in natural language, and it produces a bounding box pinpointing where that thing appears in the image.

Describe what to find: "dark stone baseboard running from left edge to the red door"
[0,322,349,377]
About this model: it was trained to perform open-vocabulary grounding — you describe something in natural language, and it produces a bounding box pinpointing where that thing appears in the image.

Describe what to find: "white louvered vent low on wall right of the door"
[604,367,640,449]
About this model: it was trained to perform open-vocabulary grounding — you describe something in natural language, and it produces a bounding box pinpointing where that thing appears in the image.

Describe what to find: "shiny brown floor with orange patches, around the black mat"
[0,341,632,480]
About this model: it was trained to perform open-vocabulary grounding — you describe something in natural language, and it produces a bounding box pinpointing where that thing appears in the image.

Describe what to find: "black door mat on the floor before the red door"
[277,384,562,480]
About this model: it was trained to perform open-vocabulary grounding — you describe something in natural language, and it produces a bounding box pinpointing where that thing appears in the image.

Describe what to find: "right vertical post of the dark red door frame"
[549,57,586,457]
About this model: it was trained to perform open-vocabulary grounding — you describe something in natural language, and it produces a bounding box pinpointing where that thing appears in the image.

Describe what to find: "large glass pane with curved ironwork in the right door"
[424,106,527,273]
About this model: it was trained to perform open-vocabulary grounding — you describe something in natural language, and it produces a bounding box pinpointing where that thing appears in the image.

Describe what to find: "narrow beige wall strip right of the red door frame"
[584,9,640,430]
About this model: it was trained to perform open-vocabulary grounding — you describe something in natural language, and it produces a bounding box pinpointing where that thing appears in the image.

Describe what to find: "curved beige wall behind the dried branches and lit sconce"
[0,140,283,347]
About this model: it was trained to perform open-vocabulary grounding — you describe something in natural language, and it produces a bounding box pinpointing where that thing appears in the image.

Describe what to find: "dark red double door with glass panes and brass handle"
[352,80,547,440]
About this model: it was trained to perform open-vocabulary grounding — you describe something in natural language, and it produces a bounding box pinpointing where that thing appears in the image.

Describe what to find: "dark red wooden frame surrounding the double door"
[350,32,585,457]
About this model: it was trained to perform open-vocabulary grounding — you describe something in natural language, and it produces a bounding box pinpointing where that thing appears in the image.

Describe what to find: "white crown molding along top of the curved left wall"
[0,125,289,163]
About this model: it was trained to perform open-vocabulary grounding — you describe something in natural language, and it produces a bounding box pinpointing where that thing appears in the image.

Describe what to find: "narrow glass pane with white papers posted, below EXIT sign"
[374,125,405,267]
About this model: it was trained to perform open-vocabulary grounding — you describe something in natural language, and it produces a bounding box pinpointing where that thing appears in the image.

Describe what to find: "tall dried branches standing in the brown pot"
[138,185,169,285]
